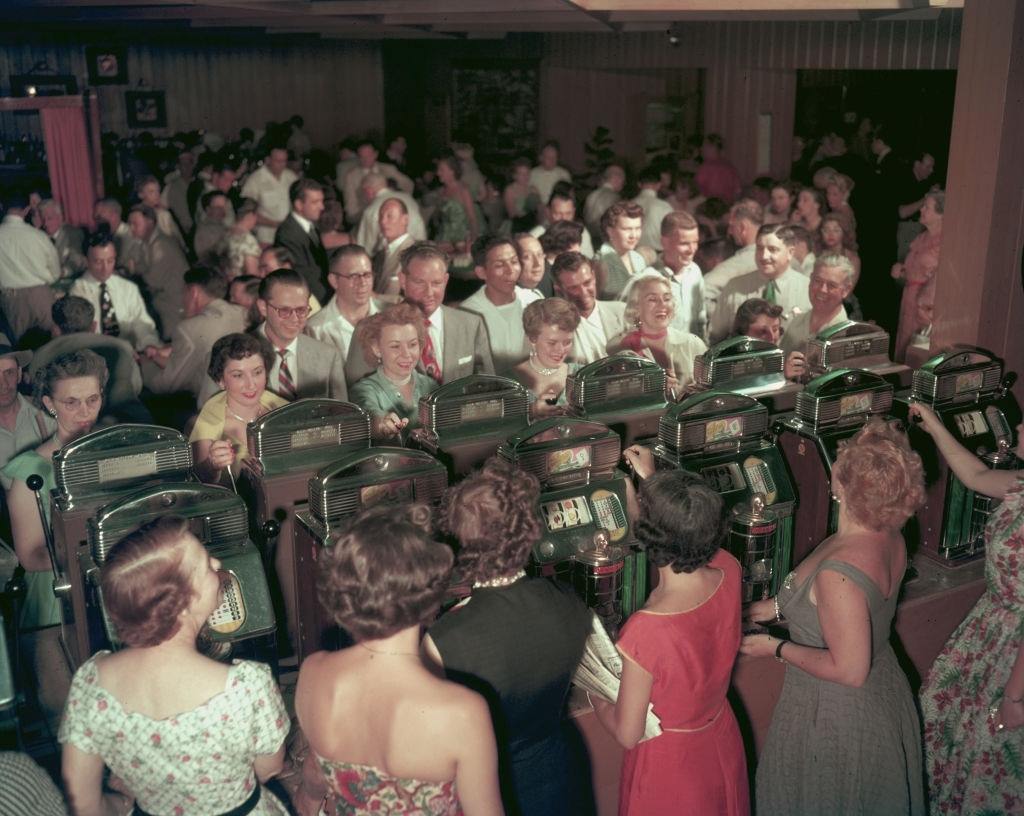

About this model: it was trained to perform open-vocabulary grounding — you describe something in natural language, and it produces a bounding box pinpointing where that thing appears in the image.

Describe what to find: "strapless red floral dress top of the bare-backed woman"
[316,754,462,816]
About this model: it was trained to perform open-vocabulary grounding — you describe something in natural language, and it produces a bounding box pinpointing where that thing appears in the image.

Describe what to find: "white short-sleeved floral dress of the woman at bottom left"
[58,652,290,816]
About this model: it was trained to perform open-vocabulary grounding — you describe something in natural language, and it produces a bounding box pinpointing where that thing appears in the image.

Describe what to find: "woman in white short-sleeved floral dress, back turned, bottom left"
[59,516,290,816]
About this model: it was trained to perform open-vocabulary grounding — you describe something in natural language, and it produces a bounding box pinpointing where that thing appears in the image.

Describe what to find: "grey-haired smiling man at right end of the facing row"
[778,254,857,377]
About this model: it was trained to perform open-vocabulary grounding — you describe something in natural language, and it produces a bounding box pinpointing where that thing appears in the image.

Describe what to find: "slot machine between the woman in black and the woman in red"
[498,417,647,629]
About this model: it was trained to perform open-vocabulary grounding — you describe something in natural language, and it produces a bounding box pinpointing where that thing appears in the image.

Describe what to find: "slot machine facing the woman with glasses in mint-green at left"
[50,425,193,670]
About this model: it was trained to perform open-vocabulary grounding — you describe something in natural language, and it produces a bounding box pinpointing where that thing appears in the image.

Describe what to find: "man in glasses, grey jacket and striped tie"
[255,269,348,400]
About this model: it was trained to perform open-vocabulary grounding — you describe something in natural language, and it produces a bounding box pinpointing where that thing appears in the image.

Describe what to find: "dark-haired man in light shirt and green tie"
[709,224,811,343]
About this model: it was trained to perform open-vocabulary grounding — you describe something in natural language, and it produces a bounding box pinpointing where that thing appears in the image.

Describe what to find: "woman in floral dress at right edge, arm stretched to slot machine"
[910,404,1024,816]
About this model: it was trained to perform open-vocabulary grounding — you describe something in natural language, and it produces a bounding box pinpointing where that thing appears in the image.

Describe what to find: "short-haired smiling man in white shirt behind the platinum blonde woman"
[654,210,708,341]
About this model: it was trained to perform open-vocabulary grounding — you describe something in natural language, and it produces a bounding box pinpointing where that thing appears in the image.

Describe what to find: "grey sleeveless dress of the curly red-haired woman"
[757,559,925,816]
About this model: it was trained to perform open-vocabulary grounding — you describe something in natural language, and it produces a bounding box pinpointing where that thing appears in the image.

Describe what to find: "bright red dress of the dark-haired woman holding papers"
[618,550,751,816]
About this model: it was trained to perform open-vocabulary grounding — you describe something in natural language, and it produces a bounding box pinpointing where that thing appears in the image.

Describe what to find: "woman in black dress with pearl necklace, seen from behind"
[424,458,591,816]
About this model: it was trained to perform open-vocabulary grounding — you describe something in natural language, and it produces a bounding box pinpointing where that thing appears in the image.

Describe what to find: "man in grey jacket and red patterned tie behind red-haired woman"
[345,241,495,383]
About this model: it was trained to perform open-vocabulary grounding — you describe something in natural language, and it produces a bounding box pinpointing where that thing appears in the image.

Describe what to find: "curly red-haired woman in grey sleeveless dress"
[740,421,925,816]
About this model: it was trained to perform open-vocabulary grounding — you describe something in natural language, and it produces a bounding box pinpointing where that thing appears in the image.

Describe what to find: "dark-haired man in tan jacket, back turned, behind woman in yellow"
[142,268,246,398]
